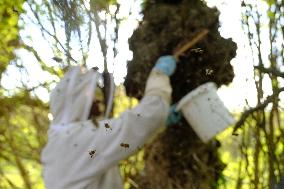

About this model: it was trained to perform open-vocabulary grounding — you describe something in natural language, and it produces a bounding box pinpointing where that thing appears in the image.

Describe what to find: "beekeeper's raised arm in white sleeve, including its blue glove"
[91,56,176,172]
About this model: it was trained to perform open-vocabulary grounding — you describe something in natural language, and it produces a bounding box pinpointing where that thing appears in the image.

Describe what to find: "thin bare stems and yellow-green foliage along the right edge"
[229,0,284,188]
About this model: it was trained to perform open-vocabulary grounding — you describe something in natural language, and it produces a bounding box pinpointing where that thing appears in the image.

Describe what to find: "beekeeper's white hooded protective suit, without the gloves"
[41,67,172,189]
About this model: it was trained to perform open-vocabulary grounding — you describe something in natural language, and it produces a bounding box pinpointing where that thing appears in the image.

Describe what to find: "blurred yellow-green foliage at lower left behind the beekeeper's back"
[0,102,48,188]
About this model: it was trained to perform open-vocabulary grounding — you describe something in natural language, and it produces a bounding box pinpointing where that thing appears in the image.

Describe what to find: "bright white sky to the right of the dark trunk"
[207,0,281,111]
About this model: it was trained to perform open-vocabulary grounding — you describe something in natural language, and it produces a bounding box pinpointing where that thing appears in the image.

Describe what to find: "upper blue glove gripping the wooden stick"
[154,55,176,76]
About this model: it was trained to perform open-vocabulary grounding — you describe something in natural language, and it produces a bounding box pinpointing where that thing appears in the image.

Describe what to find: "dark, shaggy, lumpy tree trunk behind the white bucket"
[124,0,236,189]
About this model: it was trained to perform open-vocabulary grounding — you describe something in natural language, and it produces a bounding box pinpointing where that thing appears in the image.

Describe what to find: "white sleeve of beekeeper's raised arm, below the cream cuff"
[92,96,169,171]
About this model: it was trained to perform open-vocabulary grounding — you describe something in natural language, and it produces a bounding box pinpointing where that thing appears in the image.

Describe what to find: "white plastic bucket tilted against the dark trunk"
[177,82,235,143]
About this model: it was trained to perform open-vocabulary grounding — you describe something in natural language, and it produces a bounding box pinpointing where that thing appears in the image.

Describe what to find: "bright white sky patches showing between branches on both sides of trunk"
[2,0,276,111]
